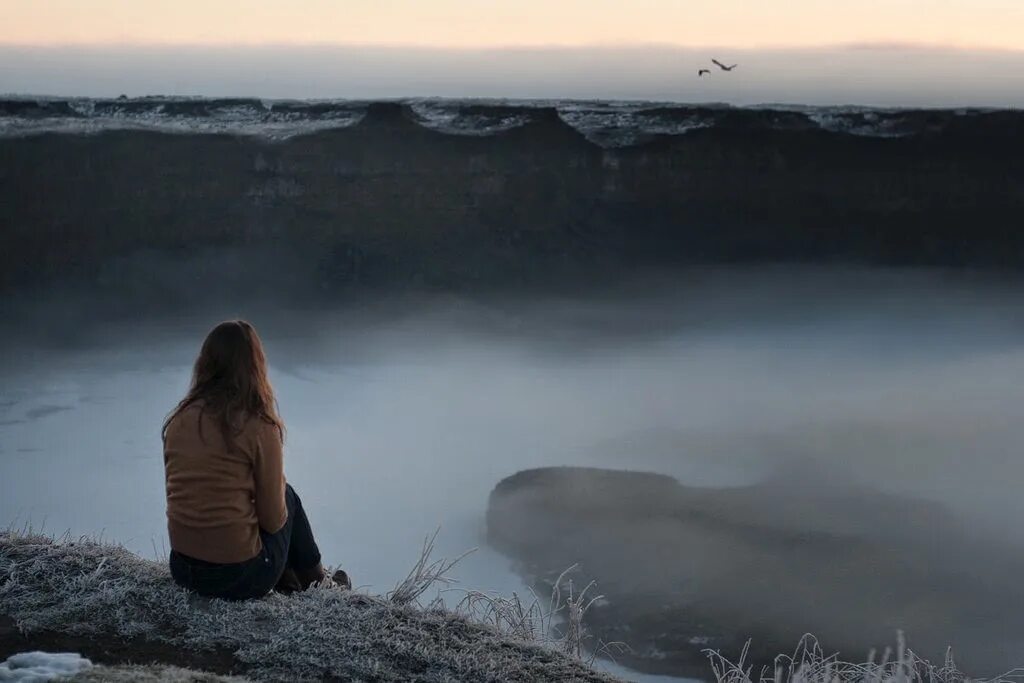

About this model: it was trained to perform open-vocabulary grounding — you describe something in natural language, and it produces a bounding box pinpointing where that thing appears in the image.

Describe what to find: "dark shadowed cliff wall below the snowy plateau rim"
[0,104,1024,287]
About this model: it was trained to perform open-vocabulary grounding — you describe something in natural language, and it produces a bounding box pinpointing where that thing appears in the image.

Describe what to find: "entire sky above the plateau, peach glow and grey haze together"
[0,0,1024,106]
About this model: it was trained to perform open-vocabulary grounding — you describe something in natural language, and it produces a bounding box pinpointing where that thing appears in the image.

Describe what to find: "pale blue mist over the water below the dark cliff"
[0,267,1024,671]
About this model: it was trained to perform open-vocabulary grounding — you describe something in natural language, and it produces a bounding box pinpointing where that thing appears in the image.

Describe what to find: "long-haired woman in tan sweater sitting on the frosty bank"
[163,321,351,600]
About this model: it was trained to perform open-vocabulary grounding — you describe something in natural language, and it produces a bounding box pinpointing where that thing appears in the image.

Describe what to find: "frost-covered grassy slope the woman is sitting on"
[0,531,612,681]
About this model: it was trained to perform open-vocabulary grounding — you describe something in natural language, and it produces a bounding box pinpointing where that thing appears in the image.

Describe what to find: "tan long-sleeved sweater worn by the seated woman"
[164,405,288,563]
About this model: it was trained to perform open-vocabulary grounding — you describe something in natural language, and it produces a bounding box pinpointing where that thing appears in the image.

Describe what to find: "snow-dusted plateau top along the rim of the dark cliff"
[0,96,1007,143]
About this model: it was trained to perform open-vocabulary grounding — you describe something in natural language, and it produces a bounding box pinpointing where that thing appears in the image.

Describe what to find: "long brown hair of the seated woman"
[161,321,285,451]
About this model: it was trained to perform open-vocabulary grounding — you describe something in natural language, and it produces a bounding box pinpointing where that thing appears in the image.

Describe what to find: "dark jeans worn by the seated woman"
[171,484,321,600]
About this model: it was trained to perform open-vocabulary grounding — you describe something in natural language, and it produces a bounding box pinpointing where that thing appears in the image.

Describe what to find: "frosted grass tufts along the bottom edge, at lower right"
[705,633,1024,683]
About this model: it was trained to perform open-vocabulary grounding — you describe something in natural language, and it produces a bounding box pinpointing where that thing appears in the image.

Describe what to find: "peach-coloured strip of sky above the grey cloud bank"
[6,0,1024,50]
